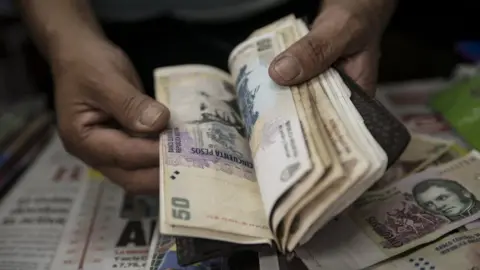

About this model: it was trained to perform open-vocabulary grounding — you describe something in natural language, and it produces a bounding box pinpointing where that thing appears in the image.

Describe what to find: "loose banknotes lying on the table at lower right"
[295,134,480,270]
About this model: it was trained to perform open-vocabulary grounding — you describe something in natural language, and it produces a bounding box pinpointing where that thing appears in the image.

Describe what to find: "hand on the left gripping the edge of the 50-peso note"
[51,40,169,193]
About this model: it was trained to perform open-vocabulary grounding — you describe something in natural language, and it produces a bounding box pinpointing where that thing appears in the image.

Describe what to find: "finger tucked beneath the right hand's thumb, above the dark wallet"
[340,49,380,96]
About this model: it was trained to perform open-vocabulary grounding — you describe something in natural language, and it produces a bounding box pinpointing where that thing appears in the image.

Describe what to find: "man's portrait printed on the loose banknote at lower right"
[412,179,480,221]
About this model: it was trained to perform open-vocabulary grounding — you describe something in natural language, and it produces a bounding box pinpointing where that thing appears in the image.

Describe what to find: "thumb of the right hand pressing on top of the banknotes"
[269,7,354,85]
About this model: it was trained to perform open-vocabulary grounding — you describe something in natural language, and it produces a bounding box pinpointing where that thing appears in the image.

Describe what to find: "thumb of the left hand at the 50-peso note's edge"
[107,78,170,132]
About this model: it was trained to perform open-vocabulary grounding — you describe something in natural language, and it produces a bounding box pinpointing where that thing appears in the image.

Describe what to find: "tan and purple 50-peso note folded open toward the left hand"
[155,65,272,243]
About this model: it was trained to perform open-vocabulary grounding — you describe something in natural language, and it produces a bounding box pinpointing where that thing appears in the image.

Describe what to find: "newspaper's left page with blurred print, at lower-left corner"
[0,134,87,270]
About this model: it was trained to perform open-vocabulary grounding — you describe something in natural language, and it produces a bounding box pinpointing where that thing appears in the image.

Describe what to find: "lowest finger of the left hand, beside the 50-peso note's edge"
[98,167,159,195]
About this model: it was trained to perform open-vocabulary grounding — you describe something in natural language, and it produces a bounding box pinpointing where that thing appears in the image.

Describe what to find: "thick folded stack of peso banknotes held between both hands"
[154,16,410,252]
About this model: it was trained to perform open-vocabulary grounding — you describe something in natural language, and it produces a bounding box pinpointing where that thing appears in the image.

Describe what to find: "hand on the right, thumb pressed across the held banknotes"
[269,0,395,95]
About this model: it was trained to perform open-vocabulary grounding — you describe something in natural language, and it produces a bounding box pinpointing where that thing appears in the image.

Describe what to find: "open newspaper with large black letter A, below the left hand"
[0,131,158,270]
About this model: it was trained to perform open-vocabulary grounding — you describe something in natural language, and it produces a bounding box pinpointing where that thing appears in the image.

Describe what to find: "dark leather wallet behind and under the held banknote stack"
[176,69,410,265]
